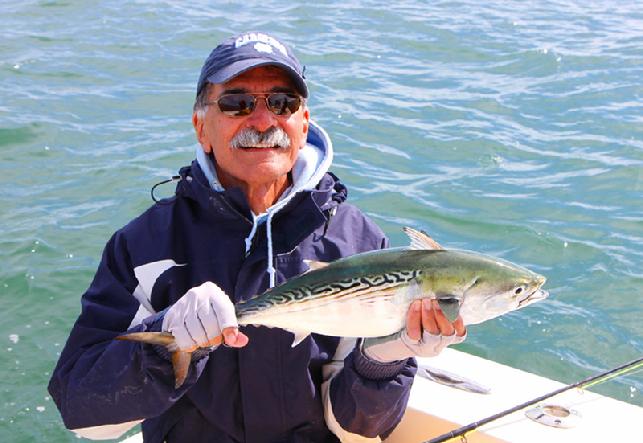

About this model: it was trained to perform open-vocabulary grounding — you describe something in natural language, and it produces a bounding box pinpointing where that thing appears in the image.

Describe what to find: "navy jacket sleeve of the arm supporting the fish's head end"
[322,222,417,443]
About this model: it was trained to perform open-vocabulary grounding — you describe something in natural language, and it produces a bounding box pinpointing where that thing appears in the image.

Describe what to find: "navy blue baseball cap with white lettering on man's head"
[196,32,308,97]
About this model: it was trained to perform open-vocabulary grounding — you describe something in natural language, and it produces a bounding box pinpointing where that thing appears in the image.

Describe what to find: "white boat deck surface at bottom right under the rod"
[386,349,643,443]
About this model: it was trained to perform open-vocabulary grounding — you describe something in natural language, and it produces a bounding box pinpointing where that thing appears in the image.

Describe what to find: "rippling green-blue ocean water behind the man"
[0,0,643,442]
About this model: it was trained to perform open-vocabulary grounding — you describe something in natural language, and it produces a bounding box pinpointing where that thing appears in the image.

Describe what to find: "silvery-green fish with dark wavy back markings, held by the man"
[116,227,549,388]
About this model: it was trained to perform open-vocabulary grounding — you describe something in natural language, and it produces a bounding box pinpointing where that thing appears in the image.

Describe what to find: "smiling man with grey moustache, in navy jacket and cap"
[49,33,465,443]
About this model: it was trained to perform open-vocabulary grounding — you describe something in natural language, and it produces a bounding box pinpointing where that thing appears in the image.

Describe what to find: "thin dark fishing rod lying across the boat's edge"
[424,357,643,443]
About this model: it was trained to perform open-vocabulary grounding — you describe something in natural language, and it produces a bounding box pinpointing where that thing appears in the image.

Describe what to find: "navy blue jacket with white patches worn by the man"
[49,150,415,443]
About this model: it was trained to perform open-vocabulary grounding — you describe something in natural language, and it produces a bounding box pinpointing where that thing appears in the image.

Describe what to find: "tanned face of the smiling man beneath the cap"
[192,66,309,188]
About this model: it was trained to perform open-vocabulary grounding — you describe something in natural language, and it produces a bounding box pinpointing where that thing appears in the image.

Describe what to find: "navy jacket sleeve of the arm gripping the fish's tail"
[49,233,207,438]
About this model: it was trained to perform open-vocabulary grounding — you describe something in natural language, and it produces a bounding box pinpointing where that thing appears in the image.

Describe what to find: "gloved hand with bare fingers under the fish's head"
[362,298,467,363]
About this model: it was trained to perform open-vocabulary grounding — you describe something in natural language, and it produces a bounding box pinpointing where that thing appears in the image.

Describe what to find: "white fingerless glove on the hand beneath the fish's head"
[362,328,467,363]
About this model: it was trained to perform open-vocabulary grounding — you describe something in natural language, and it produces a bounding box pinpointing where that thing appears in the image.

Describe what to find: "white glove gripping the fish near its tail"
[162,282,238,352]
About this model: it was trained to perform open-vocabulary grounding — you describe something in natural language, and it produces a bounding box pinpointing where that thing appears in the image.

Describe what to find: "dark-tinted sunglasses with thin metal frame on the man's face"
[206,92,301,117]
